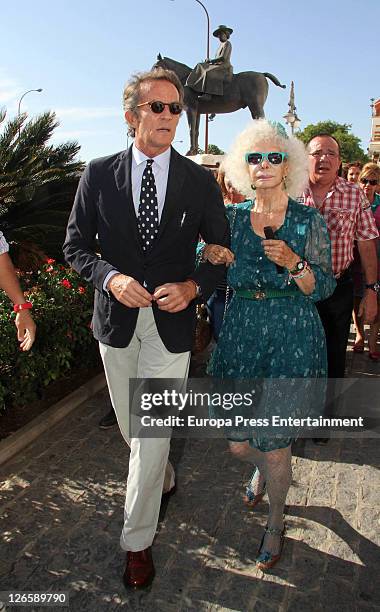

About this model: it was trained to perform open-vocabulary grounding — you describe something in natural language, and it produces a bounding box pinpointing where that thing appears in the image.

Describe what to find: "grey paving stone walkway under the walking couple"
[0,338,380,612]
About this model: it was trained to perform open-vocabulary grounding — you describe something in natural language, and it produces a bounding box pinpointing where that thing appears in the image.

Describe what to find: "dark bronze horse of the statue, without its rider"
[153,53,286,155]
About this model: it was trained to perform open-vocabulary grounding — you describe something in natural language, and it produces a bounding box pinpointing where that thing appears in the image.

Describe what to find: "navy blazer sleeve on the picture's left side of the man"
[63,162,115,293]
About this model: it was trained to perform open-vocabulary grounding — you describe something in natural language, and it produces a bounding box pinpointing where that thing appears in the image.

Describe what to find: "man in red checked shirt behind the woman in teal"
[303,134,378,440]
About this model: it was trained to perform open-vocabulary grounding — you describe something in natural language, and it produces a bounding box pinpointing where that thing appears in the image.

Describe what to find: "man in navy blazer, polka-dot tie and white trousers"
[64,69,229,588]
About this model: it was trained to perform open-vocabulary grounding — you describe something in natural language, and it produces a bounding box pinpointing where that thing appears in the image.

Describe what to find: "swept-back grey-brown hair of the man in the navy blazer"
[123,67,184,137]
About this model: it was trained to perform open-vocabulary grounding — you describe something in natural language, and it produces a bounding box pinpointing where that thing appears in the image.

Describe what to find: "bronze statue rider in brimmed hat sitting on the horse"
[186,25,233,102]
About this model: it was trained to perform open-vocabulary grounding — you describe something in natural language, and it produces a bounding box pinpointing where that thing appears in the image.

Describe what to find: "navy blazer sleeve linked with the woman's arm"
[189,172,230,301]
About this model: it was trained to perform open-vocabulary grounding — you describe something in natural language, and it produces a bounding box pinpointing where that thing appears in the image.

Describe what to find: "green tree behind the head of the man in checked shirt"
[296,121,369,163]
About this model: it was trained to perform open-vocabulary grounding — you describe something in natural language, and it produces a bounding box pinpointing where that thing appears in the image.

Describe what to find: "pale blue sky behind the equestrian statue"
[0,0,380,161]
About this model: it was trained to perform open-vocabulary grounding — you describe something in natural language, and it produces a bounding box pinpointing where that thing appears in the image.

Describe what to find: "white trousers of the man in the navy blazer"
[99,307,190,551]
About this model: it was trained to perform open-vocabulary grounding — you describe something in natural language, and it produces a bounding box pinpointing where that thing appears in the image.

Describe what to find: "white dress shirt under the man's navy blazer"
[103,143,171,291]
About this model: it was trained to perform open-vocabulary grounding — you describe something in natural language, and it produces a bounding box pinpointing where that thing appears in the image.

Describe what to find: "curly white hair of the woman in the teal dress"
[223,119,308,199]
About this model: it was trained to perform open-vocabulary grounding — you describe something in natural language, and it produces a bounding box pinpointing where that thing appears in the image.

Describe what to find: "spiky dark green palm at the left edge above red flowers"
[0,112,84,269]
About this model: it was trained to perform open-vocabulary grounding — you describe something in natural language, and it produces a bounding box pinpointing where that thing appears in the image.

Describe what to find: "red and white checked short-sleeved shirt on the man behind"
[299,177,379,277]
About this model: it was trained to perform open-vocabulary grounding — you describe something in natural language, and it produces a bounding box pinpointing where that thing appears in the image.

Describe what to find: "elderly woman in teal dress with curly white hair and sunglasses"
[203,119,335,570]
